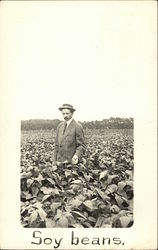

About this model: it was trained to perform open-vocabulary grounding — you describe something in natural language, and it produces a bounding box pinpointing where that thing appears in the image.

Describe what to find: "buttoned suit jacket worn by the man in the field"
[54,119,85,162]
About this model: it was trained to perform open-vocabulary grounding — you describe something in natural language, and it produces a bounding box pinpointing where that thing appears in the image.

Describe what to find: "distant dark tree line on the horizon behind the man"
[21,117,134,130]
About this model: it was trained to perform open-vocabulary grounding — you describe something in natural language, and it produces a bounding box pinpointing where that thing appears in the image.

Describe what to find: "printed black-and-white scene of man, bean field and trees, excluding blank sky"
[21,104,134,228]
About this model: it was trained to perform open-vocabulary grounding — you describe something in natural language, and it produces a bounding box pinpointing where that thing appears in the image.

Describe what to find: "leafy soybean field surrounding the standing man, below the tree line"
[21,129,134,228]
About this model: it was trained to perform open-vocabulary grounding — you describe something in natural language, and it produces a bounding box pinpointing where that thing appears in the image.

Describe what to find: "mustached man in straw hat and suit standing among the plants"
[53,104,85,166]
